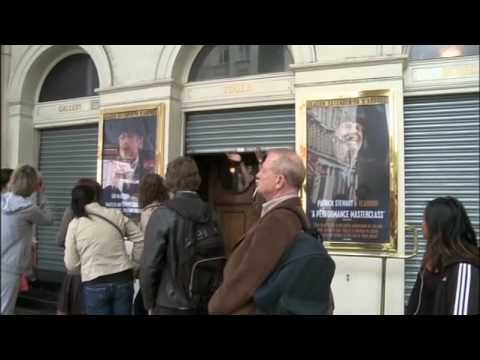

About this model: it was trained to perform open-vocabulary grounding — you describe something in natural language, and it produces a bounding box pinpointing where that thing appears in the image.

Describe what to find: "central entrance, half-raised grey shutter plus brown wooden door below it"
[185,105,295,250]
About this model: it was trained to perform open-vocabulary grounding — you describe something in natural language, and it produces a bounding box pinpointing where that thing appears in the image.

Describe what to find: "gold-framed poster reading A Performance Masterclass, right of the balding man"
[304,90,399,254]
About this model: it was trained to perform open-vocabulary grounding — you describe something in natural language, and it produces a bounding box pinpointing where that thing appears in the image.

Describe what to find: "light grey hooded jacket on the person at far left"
[1,192,53,274]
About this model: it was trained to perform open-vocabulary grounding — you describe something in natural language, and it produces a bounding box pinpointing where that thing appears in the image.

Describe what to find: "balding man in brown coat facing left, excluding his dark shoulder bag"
[208,150,307,314]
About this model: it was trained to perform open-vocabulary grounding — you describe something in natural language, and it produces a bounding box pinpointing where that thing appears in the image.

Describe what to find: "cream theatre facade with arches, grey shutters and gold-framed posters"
[1,45,480,314]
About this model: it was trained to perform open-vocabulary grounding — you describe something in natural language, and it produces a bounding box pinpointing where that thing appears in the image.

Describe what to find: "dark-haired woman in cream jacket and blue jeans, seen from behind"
[65,185,143,315]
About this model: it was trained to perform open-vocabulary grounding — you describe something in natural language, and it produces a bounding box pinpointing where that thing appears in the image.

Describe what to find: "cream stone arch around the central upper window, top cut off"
[156,45,317,84]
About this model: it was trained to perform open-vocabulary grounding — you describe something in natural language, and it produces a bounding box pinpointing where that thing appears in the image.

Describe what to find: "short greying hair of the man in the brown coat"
[268,149,305,189]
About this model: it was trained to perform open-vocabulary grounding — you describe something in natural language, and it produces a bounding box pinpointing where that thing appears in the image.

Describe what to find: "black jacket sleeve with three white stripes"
[451,263,480,315]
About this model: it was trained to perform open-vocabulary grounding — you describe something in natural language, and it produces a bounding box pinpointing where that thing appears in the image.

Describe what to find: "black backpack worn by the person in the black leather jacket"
[164,199,226,313]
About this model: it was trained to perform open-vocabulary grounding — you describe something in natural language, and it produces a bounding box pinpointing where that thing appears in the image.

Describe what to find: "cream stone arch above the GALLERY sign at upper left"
[8,45,112,105]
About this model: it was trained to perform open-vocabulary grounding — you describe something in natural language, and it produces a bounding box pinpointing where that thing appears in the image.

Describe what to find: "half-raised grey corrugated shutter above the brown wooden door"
[185,106,295,154]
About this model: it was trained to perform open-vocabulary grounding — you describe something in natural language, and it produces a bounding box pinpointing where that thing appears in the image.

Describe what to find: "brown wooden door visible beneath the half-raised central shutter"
[194,153,261,253]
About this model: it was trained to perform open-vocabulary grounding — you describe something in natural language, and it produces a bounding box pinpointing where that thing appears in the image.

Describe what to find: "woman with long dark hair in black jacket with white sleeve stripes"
[407,197,480,315]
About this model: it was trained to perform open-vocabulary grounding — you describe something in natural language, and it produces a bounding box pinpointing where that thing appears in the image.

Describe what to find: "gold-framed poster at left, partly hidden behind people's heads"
[97,103,165,220]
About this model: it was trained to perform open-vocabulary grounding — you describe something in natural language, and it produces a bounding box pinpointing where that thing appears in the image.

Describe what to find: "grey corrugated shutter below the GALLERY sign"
[37,125,98,272]
